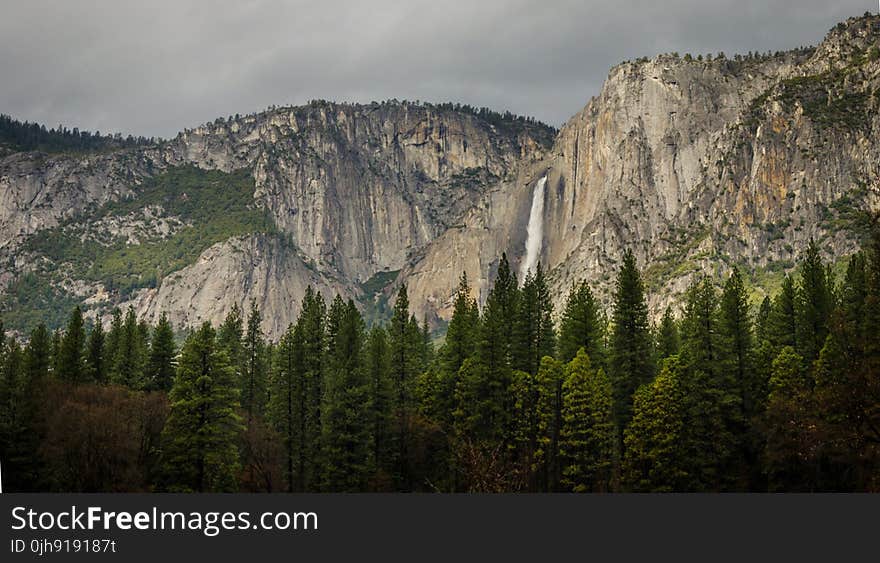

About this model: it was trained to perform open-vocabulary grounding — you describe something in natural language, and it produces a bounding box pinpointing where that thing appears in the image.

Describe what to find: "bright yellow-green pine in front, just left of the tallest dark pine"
[560,350,615,493]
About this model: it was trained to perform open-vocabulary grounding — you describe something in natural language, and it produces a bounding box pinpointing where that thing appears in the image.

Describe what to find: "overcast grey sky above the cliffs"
[0,0,878,137]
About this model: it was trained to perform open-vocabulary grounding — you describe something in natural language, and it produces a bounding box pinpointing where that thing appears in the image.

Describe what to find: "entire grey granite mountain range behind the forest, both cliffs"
[0,16,880,335]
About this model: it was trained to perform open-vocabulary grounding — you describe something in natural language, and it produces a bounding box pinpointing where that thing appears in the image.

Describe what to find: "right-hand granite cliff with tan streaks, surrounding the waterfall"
[402,17,880,316]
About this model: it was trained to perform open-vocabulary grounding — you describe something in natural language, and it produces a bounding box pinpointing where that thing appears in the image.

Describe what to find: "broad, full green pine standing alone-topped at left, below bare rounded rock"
[162,323,242,492]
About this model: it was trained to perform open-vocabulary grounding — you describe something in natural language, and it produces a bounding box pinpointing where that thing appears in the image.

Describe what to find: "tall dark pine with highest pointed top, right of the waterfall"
[609,250,654,433]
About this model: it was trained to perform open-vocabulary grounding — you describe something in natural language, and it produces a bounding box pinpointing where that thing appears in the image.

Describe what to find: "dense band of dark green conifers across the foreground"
[0,231,880,492]
